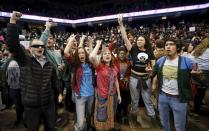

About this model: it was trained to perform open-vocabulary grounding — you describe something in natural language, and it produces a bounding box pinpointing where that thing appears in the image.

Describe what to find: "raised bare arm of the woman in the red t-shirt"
[89,40,102,67]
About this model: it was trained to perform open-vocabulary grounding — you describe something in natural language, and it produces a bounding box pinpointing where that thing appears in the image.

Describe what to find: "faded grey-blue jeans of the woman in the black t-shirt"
[129,76,155,117]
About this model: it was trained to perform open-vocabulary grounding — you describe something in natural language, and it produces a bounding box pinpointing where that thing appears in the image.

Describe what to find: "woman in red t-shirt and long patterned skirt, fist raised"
[89,40,121,130]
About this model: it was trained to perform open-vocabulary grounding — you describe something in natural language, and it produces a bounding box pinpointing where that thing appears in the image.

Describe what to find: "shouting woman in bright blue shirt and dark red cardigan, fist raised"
[64,35,94,131]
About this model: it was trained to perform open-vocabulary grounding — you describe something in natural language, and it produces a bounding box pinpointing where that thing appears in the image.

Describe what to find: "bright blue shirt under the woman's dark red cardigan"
[80,64,94,96]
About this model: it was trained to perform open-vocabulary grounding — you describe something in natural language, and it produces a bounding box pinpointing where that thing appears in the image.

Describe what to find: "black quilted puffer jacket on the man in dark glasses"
[7,24,57,107]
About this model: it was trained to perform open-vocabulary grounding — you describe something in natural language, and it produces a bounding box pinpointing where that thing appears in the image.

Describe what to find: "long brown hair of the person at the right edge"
[193,37,209,57]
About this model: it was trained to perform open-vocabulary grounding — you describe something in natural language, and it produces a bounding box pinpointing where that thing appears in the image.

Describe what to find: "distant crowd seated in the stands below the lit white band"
[0,18,209,51]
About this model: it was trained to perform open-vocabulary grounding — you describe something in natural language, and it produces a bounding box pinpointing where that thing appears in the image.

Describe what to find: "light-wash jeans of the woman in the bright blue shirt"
[75,96,94,131]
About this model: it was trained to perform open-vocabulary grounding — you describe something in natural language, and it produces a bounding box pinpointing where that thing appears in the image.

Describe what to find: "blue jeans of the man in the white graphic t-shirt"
[158,91,187,131]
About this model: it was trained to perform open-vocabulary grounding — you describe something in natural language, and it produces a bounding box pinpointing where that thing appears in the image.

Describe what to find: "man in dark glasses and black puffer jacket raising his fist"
[7,11,61,131]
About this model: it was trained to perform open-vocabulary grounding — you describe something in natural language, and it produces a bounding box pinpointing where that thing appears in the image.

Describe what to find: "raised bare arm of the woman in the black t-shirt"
[118,14,132,51]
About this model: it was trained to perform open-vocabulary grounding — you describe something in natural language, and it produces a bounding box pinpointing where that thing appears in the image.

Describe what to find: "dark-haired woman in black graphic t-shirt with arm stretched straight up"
[118,15,156,125]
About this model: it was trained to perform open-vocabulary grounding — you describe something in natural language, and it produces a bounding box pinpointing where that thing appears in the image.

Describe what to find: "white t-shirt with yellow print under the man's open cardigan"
[162,57,179,95]
